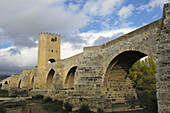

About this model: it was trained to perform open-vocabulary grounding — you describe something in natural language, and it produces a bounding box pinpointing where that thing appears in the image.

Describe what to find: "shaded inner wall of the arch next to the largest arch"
[65,66,78,89]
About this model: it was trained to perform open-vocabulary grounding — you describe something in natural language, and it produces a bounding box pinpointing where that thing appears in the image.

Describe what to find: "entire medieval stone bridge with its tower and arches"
[2,4,170,113]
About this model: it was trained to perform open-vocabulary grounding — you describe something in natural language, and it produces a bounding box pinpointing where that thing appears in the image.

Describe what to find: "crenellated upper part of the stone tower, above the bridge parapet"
[37,32,60,70]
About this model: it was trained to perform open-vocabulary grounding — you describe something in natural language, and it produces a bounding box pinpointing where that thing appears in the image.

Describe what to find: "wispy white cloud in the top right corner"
[136,0,170,12]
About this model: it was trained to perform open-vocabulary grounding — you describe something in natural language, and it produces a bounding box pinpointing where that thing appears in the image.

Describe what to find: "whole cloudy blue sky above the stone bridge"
[0,0,170,75]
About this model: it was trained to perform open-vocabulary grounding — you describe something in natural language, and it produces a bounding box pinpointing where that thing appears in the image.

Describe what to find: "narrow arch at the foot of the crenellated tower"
[46,69,55,89]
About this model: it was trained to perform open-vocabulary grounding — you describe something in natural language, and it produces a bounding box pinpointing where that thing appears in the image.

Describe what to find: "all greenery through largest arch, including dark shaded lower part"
[128,57,157,113]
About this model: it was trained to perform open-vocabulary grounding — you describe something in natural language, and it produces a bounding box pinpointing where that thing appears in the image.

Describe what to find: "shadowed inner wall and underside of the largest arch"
[103,51,147,104]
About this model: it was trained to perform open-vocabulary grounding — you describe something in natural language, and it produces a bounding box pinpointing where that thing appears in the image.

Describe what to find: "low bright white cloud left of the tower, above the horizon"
[0,47,38,75]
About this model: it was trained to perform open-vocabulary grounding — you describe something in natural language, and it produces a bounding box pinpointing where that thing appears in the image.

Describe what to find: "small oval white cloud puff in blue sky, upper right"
[118,4,134,18]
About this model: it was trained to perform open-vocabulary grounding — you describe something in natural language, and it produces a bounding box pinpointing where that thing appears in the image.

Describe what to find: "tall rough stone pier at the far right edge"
[156,3,170,113]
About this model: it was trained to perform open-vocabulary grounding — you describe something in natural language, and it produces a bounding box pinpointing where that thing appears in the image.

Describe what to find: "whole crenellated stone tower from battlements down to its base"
[34,32,60,89]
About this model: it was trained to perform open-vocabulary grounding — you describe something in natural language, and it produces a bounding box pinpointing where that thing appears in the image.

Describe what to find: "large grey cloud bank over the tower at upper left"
[0,0,90,48]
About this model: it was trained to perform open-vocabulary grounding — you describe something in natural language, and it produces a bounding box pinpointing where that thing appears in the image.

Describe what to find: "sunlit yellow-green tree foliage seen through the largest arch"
[128,57,156,90]
